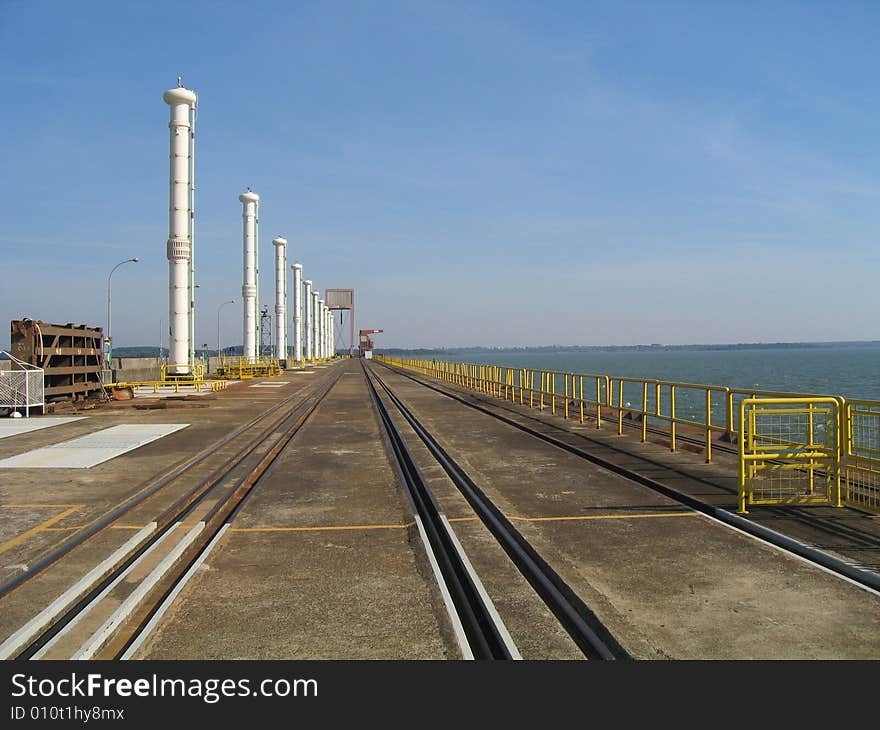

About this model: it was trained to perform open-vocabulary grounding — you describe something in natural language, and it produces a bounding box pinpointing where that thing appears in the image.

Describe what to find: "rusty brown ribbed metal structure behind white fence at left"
[9,319,105,403]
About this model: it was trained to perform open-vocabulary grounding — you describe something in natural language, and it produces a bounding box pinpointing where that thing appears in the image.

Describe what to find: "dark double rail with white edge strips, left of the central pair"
[361,362,512,659]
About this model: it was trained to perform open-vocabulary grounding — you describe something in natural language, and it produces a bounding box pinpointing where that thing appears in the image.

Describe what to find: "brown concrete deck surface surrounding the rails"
[0,361,880,659]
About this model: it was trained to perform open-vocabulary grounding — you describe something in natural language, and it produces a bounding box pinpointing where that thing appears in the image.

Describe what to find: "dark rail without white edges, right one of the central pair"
[365,366,631,660]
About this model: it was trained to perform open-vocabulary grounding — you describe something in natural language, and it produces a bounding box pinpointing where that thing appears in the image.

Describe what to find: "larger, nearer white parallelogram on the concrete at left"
[0,423,189,469]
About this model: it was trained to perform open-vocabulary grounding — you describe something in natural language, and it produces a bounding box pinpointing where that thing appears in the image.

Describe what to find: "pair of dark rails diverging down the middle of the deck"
[363,365,631,660]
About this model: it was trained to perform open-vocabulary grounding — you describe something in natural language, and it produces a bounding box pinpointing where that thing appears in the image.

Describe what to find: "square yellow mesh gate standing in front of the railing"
[737,398,843,514]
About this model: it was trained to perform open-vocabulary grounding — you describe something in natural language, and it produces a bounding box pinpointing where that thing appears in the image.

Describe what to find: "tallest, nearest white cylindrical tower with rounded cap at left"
[162,86,196,375]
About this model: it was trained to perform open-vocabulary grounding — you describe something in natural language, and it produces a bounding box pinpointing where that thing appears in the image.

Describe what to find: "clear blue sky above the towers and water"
[0,0,880,347]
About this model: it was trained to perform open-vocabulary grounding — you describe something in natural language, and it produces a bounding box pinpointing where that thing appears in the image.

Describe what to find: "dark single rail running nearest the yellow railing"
[382,363,880,591]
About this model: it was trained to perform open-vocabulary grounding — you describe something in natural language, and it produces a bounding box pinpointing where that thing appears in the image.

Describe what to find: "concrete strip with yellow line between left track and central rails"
[136,362,458,660]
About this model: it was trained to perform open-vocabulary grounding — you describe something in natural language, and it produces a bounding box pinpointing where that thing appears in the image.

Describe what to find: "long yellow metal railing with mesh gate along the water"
[374,355,880,513]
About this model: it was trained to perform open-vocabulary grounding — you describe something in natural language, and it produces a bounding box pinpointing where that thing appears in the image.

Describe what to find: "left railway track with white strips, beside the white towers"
[0,366,339,659]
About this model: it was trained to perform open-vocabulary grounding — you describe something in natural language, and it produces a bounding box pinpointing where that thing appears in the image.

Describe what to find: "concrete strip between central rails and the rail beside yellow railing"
[381,369,880,660]
